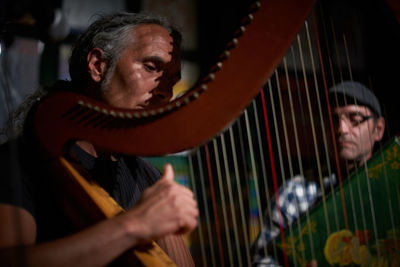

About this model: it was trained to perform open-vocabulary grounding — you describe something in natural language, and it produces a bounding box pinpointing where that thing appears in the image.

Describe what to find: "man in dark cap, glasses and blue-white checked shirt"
[252,81,385,267]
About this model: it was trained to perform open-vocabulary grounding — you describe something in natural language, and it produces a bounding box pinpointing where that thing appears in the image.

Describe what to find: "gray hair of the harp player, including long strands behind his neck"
[0,13,182,143]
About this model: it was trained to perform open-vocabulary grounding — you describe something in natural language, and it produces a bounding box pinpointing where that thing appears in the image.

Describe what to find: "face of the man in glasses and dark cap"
[333,105,384,163]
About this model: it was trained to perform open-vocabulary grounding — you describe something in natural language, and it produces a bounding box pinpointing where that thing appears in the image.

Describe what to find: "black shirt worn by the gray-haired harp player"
[0,138,160,242]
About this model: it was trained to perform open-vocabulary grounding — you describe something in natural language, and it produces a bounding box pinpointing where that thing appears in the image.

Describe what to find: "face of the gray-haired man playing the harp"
[103,24,178,109]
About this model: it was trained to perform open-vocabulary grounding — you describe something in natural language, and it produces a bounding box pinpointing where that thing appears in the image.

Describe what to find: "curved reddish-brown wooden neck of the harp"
[35,0,314,159]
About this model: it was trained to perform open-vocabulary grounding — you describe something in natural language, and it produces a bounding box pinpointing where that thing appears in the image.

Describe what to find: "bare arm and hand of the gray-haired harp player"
[0,166,198,267]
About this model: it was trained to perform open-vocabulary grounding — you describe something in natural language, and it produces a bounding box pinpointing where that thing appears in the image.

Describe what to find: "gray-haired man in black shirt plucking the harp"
[0,13,198,266]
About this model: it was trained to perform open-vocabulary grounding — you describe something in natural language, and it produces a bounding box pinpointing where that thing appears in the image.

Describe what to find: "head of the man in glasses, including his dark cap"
[329,81,385,171]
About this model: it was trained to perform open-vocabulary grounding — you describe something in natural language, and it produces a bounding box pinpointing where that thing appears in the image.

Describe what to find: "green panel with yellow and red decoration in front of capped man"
[277,137,400,266]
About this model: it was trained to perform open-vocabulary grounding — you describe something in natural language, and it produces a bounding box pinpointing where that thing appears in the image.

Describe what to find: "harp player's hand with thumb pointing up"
[122,164,199,243]
